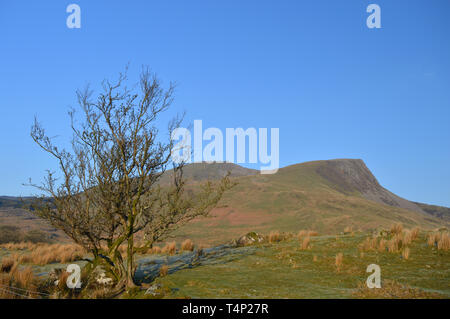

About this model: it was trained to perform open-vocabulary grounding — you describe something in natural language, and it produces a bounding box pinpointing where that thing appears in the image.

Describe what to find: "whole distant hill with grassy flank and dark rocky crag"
[0,159,450,244]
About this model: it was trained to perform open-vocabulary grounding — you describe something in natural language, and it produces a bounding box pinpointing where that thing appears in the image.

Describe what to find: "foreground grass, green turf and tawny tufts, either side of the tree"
[0,229,450,298]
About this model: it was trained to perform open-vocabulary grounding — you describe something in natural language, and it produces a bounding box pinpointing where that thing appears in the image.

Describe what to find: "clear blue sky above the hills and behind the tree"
[0,0,450,206]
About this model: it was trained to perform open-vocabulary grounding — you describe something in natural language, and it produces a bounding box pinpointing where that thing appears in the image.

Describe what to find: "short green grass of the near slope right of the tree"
[156,234,450,298]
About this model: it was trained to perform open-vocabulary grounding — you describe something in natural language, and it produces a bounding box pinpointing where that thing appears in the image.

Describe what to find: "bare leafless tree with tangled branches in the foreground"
[30,69,232,289]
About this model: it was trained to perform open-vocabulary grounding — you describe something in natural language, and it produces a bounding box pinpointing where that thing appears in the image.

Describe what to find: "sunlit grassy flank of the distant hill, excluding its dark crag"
[176,161,447,248]
